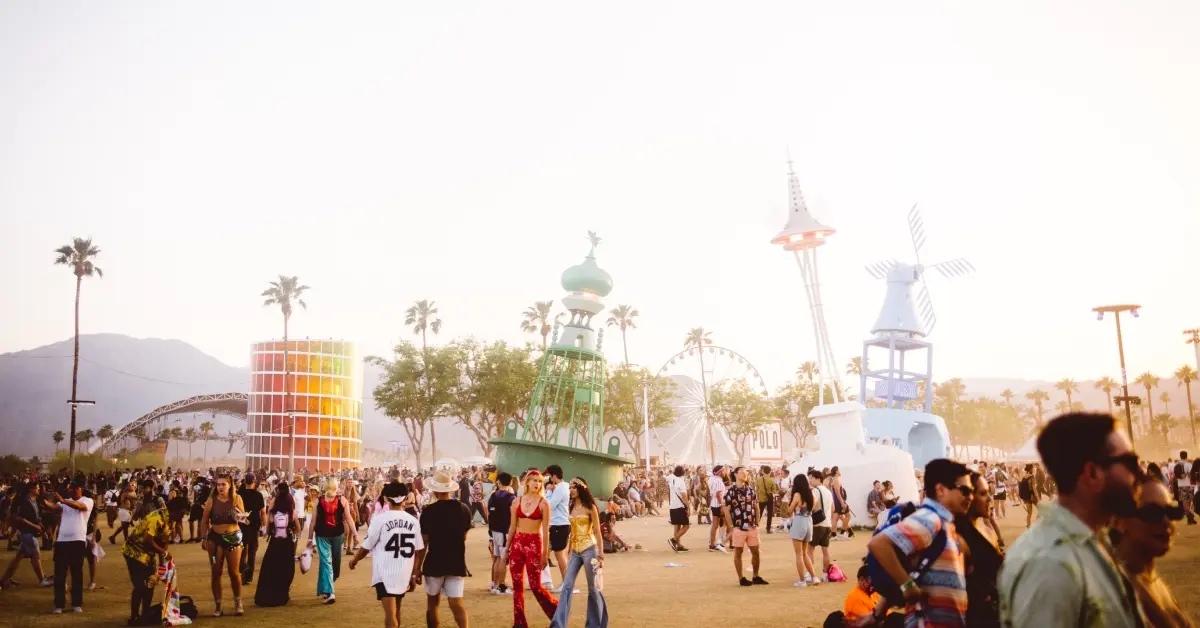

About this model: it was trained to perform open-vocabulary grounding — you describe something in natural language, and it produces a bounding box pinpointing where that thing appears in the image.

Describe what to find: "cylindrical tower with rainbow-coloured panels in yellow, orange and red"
[246,340,362,473]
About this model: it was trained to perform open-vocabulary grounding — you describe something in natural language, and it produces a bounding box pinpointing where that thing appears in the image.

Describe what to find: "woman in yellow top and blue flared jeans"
[550,478,608,628]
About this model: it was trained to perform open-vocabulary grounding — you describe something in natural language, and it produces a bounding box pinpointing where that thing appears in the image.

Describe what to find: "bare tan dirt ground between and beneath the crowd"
[0,512,1200,628]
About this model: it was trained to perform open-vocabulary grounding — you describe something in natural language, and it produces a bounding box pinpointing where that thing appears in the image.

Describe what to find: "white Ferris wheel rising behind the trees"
[652,345,767,463]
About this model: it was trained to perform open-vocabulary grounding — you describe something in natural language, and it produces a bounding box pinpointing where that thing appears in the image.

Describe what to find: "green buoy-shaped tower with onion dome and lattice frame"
[491,232,632,497]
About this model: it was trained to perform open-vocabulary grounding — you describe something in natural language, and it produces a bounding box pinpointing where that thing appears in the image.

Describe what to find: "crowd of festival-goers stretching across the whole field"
[0,414,1200,627]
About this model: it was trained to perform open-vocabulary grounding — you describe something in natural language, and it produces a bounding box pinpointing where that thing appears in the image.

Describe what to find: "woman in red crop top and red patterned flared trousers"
[509,469,558,628]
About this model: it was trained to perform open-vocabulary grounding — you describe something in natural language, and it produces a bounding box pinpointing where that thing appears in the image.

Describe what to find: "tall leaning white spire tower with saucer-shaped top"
[770,159,841,405]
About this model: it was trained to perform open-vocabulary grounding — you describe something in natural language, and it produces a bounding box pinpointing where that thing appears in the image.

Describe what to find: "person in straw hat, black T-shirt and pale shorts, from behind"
[421,471,470,628]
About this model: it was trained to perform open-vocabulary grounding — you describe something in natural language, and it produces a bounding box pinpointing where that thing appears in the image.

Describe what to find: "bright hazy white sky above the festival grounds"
[0,0,1200,388]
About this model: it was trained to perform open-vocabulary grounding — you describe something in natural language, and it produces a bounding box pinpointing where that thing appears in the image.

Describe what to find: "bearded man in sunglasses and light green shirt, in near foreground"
[1000,413,1146,628]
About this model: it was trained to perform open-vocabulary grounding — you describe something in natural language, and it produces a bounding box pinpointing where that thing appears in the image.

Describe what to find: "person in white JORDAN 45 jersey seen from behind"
[350,482,425,628]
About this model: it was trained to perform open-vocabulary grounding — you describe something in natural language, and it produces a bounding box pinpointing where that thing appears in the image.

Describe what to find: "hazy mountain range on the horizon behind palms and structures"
[0,334,1200,461]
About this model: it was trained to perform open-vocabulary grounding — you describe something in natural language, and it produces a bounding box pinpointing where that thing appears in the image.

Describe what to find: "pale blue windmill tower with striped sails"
[859,205,974,413]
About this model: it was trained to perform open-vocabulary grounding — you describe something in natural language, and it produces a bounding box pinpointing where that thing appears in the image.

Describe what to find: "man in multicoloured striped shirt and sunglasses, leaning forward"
[868,459,974,628]
